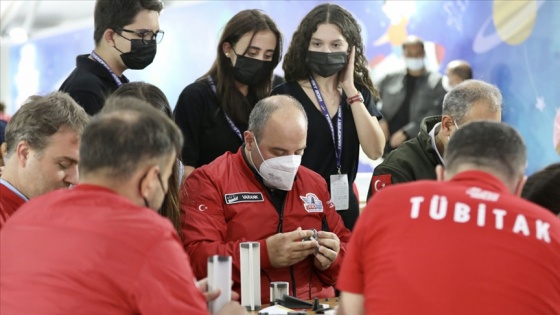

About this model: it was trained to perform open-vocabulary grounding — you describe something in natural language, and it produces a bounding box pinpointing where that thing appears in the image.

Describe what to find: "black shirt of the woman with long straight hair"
[173,80,247,168]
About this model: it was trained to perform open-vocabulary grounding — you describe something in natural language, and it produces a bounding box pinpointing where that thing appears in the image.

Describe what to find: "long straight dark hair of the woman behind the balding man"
[199,9,282,126]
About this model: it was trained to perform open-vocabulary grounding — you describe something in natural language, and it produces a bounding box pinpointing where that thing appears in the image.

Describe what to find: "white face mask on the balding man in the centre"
[249,137,301,191]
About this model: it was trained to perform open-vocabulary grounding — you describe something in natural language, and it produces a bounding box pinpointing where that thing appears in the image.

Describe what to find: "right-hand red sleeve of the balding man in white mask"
[317,188,352,285]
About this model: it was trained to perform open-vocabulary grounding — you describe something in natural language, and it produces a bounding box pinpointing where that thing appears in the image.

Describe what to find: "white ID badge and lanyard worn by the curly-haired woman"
[309,76,350,211]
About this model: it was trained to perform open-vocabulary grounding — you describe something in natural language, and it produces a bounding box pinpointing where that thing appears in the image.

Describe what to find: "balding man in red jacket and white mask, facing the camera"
[181,95,350,303]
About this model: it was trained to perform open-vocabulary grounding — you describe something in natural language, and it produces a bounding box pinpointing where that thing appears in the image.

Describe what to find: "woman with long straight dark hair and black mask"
[173,10,282,176]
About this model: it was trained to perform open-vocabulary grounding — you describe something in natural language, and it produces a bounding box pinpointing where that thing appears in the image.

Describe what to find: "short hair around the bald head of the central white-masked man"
[248,95,307,138]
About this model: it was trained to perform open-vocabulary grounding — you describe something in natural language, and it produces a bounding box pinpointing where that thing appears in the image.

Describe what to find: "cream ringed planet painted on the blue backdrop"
[473,0,546,54]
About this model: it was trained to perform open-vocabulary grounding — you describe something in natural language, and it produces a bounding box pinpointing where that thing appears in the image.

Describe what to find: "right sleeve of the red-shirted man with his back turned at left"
[132,236,208,315]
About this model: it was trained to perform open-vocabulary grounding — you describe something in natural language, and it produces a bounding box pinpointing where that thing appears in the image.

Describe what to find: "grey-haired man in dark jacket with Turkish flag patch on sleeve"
[368,80,502,199]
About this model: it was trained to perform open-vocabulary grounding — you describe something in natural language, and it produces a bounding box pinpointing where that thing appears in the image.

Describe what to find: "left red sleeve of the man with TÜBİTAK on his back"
[336,201,373,294]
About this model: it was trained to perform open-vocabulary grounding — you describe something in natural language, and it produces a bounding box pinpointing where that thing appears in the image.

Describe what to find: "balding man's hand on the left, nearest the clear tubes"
[266,228,319,268]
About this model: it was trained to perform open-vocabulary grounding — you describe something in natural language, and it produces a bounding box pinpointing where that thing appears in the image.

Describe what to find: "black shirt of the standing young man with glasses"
[59,54,128,115]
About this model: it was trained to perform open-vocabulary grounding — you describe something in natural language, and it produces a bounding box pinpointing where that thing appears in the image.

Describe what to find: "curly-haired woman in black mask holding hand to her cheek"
[272,4,385,229]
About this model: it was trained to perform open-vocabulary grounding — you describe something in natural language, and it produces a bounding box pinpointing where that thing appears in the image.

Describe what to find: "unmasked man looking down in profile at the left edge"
[0,92,89,229]
